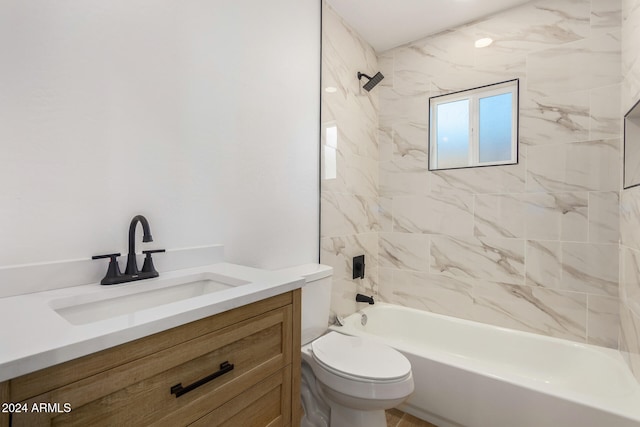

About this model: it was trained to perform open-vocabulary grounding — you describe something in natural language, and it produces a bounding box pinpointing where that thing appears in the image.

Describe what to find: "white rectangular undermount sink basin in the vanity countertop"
[51,273,250,325]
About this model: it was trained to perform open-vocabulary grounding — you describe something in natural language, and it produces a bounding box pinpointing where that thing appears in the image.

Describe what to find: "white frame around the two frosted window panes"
[429,79,519,170]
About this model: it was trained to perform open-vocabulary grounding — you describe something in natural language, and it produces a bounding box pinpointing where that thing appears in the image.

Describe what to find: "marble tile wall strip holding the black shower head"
[320,2,380,315]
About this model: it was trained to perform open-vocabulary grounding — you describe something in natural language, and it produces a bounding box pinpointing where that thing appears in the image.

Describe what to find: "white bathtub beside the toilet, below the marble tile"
[332,303,640,427]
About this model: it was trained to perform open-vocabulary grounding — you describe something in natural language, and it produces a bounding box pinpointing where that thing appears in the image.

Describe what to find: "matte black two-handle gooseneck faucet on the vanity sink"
[92,215,164,285]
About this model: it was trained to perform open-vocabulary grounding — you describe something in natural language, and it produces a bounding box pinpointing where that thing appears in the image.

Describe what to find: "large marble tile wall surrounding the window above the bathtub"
[378,0,624,348]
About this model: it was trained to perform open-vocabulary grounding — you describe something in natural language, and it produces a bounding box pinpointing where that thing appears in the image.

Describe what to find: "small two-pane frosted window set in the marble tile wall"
[429,79,518,170]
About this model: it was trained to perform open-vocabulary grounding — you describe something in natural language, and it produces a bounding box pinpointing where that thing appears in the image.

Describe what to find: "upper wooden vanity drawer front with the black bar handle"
[12,306,292,426]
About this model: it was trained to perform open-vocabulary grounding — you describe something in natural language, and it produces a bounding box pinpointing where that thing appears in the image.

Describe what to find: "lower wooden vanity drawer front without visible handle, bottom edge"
[190,366,291,427]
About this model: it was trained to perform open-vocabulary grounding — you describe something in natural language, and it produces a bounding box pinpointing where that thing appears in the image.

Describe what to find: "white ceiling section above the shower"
[327,0,530,52]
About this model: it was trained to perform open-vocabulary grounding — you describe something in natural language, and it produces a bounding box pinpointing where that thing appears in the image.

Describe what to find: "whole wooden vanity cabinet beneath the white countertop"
[0,289,300,427]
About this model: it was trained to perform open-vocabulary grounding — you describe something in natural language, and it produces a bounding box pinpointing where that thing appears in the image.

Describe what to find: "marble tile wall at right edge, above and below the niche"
[620,0,640,381]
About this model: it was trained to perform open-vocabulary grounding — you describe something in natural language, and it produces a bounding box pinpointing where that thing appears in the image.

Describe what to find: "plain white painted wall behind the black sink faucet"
[0,0,320,270]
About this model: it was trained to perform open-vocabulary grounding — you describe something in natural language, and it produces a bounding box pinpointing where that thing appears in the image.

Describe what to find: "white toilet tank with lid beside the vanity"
[280,264,333,345]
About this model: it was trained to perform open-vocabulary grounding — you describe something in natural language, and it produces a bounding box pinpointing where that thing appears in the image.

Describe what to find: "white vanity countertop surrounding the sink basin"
[0,263,304,381]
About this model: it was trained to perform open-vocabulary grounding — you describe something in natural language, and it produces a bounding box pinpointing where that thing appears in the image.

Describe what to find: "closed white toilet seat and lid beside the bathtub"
[311,332,411,383]
